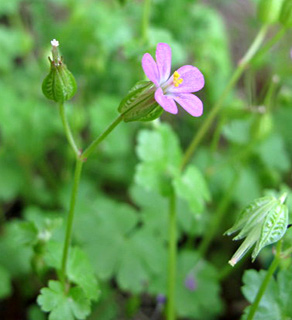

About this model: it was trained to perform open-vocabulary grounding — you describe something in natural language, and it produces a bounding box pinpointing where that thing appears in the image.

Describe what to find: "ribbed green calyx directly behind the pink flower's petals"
[118,81,163,122]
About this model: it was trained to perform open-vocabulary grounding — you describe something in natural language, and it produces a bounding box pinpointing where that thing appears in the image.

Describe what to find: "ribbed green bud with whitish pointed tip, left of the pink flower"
[42,39,77,102]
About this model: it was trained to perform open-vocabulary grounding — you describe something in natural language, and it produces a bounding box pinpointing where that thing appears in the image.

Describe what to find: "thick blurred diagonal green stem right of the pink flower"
[181,25,268,170]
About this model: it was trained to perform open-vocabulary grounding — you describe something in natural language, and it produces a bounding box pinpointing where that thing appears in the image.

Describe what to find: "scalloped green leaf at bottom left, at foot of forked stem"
[37,280,90,320]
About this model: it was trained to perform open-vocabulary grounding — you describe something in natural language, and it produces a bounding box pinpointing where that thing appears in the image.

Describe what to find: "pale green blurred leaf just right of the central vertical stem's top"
[174,166,211,214]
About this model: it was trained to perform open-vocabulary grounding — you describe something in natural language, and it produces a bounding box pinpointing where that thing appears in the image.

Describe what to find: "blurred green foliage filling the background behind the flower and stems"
[0,0,292,320]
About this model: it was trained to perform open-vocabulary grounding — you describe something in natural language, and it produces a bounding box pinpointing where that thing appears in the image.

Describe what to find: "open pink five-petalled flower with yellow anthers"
[142,43,205,117]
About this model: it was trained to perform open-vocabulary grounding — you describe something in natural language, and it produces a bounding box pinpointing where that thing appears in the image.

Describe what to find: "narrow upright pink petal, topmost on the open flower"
[156,43,171,84]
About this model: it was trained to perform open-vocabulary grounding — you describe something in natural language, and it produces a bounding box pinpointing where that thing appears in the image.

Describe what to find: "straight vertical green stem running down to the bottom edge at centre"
[167,191,177,320]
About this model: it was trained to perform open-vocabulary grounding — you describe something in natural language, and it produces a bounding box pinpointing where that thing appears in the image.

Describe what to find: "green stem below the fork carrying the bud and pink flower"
[61,158,83,285]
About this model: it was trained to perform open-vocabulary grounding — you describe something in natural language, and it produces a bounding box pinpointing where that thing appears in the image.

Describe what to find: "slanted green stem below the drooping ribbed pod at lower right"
[246,240,282,320]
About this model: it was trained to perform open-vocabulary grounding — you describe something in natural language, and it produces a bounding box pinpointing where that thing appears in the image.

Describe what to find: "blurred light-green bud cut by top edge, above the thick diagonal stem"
[257,0,283,24]
